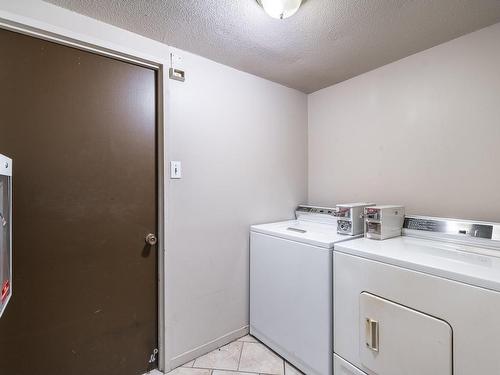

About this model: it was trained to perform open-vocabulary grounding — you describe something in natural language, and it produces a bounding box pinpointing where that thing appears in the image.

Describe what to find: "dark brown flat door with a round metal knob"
[0,30,157,375]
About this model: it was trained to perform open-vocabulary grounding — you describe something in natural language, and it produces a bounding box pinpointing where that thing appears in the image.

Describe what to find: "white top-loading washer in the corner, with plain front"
[250,206,359,375]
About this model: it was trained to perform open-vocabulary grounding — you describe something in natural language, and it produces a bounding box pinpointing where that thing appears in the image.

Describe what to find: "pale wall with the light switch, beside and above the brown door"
[0,0,307,369]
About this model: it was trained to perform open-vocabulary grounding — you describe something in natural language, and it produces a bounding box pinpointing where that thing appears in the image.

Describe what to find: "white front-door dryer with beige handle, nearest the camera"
[334,216,500,375]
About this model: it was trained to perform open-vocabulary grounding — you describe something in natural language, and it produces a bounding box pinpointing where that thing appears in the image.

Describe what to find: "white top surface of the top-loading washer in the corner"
[251,220,360,249]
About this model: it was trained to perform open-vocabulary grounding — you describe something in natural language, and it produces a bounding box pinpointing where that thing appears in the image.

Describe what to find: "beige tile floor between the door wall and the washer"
[168,335,302,375]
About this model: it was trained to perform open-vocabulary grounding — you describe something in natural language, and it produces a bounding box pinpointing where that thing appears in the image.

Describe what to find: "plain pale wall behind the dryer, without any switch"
[308,24,500,221]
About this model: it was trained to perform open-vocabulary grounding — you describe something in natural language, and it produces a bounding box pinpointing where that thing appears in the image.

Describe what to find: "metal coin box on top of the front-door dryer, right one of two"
[364,206,405,240]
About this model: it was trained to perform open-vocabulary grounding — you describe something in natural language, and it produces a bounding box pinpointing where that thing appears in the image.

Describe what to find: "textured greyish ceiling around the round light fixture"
[48,0,500,93]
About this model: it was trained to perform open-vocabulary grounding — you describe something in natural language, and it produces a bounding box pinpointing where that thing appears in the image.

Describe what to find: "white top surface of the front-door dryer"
[335,236,500,292]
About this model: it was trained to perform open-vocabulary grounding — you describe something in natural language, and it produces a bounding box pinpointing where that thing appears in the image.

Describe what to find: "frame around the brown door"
[0,10,171,372]
